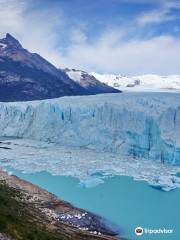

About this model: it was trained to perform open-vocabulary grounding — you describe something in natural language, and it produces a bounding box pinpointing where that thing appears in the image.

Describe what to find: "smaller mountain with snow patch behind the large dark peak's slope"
[64,68,119,94]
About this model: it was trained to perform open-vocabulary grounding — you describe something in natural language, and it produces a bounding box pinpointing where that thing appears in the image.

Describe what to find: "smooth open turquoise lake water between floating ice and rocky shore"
[5,169,180,240]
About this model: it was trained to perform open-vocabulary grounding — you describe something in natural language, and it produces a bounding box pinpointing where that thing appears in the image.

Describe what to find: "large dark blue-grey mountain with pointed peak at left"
[0,34,119,101]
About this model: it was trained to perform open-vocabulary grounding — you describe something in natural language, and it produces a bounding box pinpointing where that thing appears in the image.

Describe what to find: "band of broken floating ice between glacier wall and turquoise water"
[0,139,180,191]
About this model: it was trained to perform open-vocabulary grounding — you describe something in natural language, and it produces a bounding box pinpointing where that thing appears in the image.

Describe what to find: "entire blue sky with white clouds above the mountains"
[0,0,180,75]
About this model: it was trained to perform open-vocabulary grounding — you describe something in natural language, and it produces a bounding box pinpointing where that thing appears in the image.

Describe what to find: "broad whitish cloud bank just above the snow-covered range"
[58,33,180,75]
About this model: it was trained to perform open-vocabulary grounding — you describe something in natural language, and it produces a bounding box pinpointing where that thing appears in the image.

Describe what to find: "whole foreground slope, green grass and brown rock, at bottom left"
[0,170,121,240]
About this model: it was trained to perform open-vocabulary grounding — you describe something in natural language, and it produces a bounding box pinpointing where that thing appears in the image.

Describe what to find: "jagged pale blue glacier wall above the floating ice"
[0,93,180,165]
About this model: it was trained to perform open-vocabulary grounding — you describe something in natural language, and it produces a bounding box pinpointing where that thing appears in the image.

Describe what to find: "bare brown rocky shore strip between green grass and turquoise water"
[0,170,122,240]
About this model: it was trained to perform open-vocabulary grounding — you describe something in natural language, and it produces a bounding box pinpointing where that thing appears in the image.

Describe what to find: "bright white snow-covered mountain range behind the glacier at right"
[91,72,180,91]
